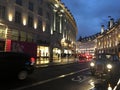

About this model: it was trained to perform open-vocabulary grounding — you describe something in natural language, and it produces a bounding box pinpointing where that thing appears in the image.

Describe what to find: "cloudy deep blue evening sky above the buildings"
[61,0,120,39]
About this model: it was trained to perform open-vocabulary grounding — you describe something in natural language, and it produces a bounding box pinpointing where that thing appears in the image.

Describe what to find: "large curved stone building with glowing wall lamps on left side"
[0,0,77,64]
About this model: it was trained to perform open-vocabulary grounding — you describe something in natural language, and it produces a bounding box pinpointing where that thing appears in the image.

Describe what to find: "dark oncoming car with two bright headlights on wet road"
[90,53,120,76]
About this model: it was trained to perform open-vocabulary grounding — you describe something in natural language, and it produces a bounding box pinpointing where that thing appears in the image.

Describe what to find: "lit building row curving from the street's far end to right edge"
[76,18,120,56]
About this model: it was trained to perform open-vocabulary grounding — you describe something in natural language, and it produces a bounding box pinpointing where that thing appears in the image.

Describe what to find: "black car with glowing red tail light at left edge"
[0,52,35,80]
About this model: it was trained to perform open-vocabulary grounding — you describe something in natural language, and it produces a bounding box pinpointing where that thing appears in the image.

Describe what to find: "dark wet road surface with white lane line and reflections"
[0,62,118,90]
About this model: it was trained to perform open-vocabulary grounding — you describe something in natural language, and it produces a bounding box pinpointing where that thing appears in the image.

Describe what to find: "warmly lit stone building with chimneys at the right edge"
[96,19,120,56]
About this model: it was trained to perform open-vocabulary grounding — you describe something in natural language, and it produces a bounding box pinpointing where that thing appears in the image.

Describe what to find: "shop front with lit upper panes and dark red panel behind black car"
[0,23,37,59]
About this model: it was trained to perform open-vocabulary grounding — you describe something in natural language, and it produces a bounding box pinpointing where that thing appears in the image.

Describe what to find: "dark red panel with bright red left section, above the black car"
[0,39,37,59]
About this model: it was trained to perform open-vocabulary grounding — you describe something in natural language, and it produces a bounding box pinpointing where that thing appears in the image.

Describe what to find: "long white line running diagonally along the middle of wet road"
[12,68,89,90]
